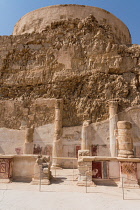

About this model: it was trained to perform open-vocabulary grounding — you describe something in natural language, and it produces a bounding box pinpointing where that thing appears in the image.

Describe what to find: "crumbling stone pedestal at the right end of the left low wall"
[32,156,51,185]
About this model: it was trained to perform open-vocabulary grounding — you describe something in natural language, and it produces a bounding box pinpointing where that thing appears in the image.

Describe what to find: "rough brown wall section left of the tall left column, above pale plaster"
[0,97,54,129]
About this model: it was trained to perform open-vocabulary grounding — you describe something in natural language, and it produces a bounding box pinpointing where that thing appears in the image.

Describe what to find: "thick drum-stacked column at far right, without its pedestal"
[117,121,134,158]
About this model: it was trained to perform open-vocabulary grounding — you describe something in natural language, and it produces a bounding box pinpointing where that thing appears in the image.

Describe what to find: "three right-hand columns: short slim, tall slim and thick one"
[81,100,134,158]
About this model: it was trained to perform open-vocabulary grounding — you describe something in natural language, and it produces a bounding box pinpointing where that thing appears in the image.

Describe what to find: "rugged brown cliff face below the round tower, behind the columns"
[0,16,140,129]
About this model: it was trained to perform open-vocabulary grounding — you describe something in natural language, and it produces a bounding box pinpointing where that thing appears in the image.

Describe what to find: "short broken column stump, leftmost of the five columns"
[23,126,34,154]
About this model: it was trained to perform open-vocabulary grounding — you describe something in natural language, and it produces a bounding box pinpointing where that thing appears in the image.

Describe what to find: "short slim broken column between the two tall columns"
[81,120,90,150]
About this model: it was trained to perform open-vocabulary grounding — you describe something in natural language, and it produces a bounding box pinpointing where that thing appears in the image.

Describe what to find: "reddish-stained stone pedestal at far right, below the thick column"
[118,162,139,188]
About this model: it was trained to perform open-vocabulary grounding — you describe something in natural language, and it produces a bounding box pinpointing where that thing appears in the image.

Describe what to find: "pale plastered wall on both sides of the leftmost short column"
[0,124,54,155]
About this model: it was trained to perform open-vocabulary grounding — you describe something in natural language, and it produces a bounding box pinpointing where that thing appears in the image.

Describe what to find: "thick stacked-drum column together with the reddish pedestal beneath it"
[117,121,139,188]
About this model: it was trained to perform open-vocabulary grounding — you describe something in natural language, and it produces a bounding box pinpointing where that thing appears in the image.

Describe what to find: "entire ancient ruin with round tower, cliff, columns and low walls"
[0,5,140,187]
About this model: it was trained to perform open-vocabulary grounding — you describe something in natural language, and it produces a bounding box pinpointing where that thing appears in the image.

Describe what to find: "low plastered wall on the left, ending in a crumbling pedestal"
[0,155,51,184]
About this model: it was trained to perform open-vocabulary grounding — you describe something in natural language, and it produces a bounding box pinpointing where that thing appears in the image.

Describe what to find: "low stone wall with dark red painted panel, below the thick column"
[78,153,140,188]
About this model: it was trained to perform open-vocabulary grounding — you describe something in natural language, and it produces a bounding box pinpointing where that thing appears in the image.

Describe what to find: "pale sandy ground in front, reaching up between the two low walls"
[0,170,140,210]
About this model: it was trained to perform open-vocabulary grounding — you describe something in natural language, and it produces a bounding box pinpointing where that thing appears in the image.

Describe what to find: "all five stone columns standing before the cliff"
[24,99,134,161]
